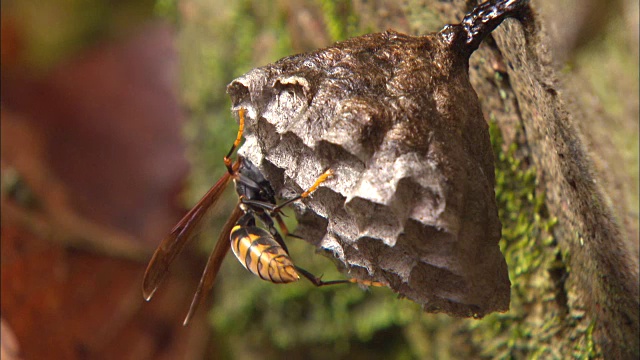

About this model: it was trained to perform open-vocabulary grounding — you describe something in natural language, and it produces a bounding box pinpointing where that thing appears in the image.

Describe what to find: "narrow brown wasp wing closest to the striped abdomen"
[183,203,244,326]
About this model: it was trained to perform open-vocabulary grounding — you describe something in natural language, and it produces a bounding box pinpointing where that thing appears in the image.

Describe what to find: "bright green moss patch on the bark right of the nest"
[468,122,598,359]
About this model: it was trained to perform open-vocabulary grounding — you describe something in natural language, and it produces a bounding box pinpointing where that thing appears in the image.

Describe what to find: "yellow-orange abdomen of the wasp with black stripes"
[230,225,300,284]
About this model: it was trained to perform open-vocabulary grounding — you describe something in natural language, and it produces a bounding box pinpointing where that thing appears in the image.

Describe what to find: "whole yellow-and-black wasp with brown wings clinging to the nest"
[142,109,382,325]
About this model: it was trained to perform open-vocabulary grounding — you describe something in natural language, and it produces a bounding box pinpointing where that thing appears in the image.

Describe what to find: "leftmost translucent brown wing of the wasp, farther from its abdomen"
[142,173,232,301]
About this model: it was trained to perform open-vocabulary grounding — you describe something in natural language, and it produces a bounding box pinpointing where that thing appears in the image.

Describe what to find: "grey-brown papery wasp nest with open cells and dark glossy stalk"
[227,1,527,317]
